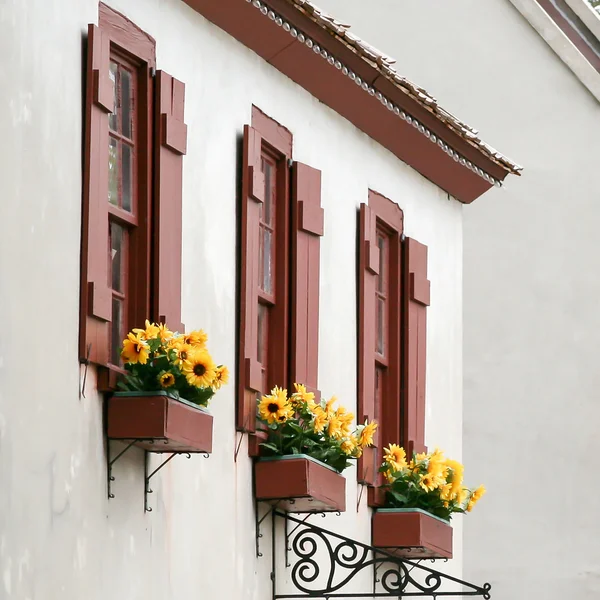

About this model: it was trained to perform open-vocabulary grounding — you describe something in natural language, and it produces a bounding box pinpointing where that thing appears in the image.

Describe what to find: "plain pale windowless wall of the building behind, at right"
[320,0,600,600]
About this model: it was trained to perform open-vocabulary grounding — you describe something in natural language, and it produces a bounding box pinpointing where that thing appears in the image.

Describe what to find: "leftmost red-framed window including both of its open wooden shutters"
[80,4,185,389]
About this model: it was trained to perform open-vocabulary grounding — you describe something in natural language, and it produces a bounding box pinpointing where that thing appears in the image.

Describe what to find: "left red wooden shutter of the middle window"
[237,125,265,432]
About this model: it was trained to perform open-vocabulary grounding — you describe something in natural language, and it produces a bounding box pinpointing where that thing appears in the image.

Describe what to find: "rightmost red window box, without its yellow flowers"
[372,508,452,559]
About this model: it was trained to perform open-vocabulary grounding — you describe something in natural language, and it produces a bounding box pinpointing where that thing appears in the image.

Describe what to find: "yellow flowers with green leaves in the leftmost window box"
[119,321,229,406]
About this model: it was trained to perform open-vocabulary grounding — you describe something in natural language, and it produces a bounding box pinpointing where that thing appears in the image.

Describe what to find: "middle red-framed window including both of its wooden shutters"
[237,107,323,454]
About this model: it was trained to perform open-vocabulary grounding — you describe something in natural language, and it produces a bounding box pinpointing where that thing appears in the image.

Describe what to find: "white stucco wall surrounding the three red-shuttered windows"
[0,0,462,600]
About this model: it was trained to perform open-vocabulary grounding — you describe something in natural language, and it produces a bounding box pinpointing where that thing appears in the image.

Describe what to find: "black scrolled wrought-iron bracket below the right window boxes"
[271,509,491,600]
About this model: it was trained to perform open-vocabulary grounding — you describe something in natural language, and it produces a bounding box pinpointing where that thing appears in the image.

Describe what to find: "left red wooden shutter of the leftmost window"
[79,25,114,365]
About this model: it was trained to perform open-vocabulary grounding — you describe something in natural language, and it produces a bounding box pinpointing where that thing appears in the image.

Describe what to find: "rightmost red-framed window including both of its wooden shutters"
[358,191,429,505]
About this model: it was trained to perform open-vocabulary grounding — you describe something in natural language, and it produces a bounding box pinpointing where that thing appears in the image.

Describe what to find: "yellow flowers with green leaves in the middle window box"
[258,383,377,473]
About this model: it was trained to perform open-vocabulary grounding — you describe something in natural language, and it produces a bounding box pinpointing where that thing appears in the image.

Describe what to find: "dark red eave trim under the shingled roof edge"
[185,0,508,203]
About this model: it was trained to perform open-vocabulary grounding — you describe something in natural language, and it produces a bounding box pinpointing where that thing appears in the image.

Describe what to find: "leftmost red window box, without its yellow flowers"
[108,392,213,453]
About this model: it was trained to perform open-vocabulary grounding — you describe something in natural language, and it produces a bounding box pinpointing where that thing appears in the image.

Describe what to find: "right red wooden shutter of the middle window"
[291,162,324,397]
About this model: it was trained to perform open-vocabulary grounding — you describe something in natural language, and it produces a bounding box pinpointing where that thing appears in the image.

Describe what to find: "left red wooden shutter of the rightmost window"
[358,204,379,485]
